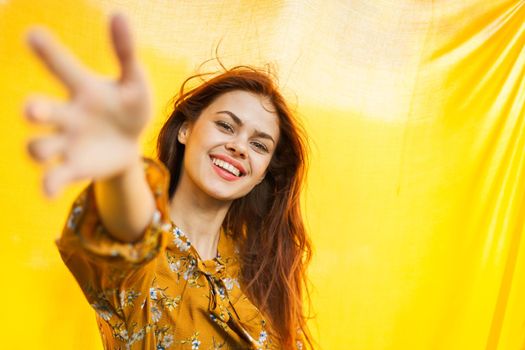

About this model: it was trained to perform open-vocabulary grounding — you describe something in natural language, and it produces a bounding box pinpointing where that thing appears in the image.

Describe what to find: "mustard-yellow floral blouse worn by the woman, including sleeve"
[56,157,284,350]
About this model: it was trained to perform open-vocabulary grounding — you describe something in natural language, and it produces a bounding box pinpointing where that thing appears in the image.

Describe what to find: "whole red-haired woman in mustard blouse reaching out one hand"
[26,16,311,349]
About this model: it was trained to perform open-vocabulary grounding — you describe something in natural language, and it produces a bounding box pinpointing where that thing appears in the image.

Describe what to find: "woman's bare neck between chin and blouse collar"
[169,176,231,260]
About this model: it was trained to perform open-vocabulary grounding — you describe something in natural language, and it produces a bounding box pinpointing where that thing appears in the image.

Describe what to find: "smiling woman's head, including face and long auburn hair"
[154,66,310,347]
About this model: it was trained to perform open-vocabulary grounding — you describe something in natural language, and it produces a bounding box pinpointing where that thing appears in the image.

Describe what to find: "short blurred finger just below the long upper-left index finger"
[24,96,73,130]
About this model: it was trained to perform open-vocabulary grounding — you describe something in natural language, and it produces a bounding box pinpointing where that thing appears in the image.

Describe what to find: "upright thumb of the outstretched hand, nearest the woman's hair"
[111,13,137,81]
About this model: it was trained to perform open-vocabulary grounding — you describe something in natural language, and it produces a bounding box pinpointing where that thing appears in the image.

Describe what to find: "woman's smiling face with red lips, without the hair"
[178,90,279,201]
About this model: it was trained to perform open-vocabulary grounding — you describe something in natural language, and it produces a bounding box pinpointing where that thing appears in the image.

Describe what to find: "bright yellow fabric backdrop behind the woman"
[0,0,525,350]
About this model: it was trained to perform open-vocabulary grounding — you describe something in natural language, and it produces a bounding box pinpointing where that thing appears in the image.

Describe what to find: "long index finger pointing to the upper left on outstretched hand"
[27,28,87,92]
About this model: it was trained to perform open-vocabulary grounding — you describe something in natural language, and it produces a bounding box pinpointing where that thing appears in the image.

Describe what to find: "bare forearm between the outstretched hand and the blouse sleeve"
[94,157,155,242]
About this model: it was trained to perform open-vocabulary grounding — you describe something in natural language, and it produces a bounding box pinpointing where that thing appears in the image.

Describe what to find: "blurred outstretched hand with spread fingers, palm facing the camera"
[24,15,151,197]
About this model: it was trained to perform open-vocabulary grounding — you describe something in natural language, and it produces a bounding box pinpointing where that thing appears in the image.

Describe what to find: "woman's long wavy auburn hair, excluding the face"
[157,64,313,348]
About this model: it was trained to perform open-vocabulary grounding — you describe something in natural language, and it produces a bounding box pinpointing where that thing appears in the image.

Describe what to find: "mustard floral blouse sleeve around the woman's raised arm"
[56,157,170,319]
